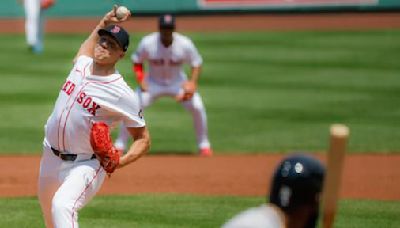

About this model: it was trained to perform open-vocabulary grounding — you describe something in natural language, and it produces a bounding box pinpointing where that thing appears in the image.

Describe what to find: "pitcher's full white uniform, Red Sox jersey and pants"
[38,56,145,228]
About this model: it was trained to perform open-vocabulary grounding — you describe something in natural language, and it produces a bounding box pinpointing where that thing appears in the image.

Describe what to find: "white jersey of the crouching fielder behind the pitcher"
[131,32,203,85]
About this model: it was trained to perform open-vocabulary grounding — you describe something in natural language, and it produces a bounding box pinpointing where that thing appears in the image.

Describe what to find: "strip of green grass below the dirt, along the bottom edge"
[0,194,400,228]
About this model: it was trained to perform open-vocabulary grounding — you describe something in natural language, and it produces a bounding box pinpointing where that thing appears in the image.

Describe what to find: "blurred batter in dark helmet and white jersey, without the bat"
[222,155,325,228]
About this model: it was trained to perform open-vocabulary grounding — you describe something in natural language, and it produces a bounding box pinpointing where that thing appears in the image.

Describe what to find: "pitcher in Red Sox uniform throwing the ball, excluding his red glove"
[38,8,150,228]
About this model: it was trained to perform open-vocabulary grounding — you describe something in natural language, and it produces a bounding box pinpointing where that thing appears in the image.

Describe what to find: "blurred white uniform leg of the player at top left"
[24,0,44,53]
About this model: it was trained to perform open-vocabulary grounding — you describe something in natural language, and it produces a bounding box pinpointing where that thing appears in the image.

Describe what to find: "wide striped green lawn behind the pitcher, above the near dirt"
[0,30,400,154]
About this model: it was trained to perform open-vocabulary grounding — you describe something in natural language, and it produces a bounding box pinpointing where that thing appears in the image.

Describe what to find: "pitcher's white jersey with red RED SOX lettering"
[44,56,145,154]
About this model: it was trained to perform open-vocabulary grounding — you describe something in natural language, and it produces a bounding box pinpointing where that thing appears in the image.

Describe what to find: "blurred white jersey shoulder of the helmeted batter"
[222,204,285,228]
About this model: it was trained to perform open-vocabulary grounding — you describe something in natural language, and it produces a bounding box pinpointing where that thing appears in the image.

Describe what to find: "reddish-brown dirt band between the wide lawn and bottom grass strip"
[0,154,400,200]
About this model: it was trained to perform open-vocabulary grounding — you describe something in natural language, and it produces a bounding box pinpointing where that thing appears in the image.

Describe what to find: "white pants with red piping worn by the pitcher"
[38,145,106,228]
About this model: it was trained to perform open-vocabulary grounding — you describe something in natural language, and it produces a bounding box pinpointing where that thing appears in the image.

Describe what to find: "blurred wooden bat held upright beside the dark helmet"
[322,124,349,228]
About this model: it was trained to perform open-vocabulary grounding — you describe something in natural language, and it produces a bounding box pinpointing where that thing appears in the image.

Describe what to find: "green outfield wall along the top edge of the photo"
[0,0,400,18]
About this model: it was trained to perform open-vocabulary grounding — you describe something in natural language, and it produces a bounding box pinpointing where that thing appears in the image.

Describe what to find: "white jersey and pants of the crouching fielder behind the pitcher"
[115,32,210,149]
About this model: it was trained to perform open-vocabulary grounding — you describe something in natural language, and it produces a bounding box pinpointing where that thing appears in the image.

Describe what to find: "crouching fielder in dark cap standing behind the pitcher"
[115,14,212,156]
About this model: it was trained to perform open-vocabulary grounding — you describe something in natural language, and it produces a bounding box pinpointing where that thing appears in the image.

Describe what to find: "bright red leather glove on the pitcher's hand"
[90,122,120,173]
